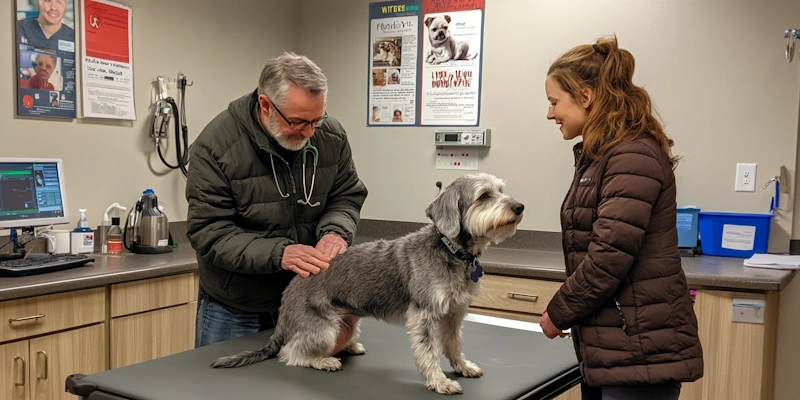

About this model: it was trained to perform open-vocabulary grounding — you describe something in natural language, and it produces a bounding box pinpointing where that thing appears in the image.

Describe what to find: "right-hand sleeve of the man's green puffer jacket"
[316,128,368,245]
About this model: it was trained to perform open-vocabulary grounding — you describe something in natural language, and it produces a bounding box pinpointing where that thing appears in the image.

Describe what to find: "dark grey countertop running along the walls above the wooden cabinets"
[0,238,795,301]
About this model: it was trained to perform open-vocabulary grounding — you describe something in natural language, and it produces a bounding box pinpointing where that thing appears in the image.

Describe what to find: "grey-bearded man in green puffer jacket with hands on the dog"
[186,53,367,347]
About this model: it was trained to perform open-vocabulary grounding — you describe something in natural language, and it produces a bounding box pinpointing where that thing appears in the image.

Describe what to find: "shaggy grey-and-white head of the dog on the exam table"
[425,172,525,243]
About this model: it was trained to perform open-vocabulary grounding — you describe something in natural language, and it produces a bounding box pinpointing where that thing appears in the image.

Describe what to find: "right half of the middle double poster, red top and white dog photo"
[419,0,484,126]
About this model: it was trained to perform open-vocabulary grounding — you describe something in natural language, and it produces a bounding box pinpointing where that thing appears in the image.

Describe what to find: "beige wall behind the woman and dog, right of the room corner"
[298,0,800,255]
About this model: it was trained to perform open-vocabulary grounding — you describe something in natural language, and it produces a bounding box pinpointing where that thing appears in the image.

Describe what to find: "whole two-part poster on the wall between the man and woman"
[367,0,484,126]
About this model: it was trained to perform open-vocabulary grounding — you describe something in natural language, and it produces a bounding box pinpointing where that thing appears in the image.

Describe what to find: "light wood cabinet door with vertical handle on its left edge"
[30,324,108,400]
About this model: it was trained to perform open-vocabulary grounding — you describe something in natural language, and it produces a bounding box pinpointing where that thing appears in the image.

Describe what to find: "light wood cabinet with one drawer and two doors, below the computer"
[0,288,108,400]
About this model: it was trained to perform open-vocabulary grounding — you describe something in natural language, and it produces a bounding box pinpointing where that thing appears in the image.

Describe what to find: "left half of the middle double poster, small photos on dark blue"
[367,1,420,126]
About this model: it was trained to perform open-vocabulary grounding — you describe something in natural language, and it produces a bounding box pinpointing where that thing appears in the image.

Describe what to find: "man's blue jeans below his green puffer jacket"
[194,288,278,348]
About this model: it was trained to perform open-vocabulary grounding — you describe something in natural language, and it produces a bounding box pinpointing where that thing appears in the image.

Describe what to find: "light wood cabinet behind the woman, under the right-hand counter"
[470,274,780,400]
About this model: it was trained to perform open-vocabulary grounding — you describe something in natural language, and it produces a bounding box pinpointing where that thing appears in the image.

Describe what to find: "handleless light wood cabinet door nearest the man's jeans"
[111,302,197,368]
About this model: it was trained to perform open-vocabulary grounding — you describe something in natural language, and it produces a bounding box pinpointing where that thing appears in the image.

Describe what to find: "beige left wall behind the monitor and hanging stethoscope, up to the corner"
[0,0,297,234]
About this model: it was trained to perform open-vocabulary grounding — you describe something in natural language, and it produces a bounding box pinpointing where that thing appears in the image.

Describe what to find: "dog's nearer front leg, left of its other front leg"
[406,306,464,394]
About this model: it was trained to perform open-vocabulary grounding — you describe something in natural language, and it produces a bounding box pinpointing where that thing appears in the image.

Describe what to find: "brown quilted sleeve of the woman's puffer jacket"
[547,143,664,330]
